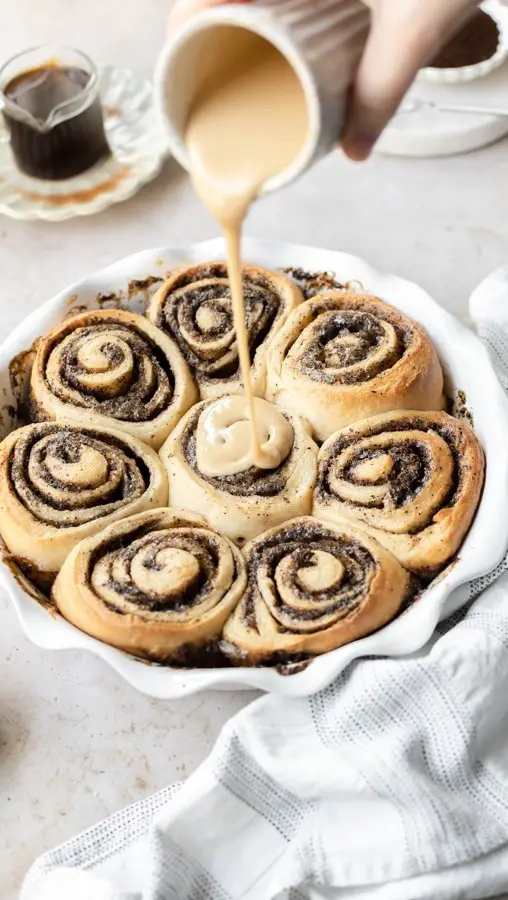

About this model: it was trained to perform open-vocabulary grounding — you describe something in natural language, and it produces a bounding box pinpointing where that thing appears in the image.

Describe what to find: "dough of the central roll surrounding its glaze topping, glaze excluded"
[160,397,317,545]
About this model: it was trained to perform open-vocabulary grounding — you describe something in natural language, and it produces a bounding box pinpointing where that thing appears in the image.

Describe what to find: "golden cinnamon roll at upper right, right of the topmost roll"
[266,291,443,441]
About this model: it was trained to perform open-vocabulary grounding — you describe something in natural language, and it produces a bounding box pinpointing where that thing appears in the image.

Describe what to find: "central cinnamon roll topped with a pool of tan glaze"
[160,396,317,545]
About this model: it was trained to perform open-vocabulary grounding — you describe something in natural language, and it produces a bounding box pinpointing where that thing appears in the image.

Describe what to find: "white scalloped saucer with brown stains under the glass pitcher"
[0,66,168,222]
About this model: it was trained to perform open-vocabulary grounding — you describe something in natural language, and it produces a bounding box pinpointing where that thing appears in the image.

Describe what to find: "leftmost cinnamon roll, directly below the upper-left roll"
[0,422,168,585]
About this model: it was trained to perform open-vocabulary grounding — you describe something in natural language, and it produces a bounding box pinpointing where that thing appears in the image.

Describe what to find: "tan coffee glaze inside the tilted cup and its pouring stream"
[185,27,308,469]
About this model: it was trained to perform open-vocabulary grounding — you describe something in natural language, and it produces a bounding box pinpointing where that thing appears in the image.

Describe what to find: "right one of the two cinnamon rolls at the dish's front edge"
[223,516,410,664]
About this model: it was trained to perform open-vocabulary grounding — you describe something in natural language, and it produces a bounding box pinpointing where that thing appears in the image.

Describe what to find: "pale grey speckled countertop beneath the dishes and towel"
[0,0,508,900]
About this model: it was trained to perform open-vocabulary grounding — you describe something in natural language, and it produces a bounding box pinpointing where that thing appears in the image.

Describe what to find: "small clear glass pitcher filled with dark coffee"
[0,47,110,180]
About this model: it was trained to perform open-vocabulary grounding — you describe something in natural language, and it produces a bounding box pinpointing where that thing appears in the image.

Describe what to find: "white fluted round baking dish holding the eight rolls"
[0,240,508,698]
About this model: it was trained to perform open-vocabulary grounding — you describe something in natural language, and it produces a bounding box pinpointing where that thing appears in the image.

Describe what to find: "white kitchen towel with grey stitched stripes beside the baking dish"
[21,268,508,900]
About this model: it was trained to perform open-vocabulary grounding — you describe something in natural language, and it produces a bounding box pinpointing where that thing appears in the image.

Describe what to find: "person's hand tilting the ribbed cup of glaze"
[169,0,479,160]
